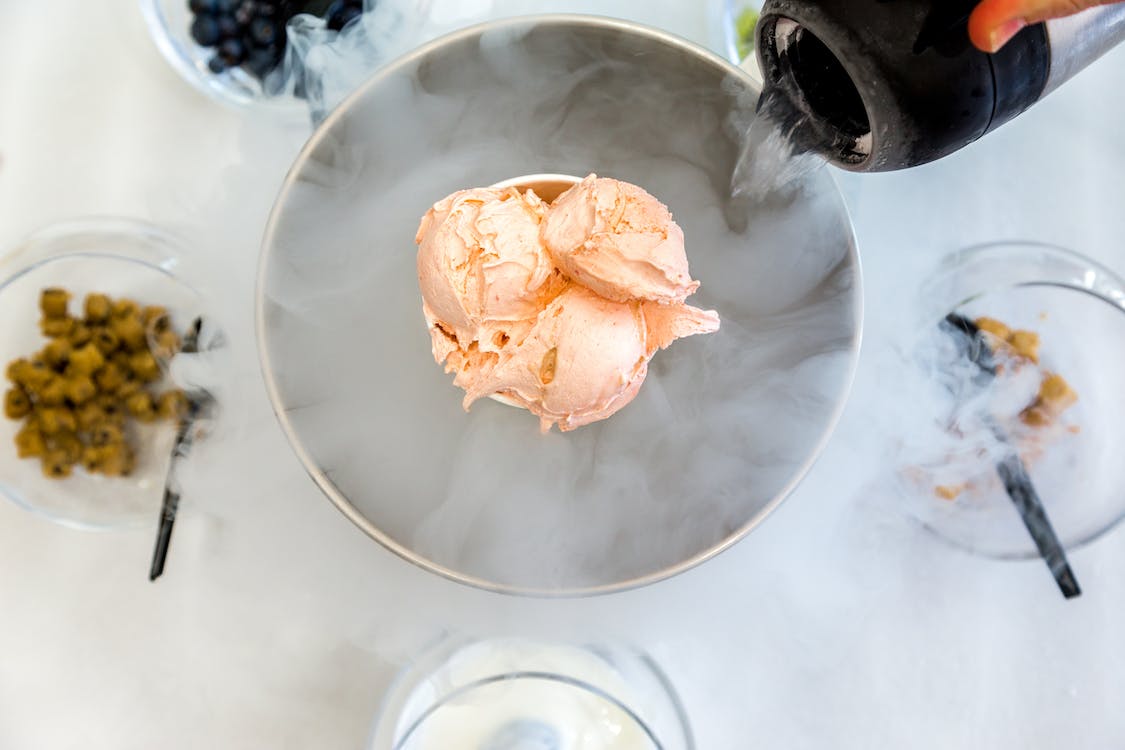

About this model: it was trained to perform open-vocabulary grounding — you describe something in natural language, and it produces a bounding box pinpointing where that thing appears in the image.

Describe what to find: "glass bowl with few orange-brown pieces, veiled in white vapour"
[888,242,1125,559]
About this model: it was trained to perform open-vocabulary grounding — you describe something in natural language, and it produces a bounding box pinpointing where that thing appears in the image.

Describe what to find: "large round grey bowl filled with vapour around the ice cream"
[258,16,862,595]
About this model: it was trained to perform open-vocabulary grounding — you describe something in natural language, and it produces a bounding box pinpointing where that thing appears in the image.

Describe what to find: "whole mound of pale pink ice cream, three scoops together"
[416,175,719,432]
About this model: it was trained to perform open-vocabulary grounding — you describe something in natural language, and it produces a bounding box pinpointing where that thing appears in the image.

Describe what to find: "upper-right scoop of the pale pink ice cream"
[542,174,700,304]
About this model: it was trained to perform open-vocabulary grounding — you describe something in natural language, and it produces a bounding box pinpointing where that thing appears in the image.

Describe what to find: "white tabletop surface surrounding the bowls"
[0,0,1125,750]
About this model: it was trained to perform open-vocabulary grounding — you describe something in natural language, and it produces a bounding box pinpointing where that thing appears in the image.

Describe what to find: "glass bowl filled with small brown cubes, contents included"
[0,219,213,528]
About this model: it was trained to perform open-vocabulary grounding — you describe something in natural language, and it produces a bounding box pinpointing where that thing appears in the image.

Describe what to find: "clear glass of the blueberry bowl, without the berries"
[141,0,431,118]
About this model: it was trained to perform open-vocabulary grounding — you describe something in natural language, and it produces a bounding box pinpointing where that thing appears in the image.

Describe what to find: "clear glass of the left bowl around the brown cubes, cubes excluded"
[0,218,201,530]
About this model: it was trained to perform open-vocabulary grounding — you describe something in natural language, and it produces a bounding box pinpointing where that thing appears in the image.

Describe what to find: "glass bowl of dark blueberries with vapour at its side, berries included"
[141,0,430,114]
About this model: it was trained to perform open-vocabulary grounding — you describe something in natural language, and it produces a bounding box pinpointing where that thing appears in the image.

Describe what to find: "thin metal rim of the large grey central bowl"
[254,13,863,598]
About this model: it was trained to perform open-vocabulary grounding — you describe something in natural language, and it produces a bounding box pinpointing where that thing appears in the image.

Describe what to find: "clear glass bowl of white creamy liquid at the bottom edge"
[368,639,695,750]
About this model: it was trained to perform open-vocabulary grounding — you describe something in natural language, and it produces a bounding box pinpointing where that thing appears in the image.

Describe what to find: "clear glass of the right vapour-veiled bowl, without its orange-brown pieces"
[906,242,1125,559]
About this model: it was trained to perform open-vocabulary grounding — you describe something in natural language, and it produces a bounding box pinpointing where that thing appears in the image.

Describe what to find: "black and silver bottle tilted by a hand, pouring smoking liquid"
[757,0,1125,172]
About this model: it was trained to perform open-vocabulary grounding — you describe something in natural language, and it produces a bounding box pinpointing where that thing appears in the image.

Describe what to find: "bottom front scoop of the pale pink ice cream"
[465,284,649,432]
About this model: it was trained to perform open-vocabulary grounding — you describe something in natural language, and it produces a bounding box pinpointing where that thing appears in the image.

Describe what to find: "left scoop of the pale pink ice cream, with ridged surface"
[415,188,554,362]
